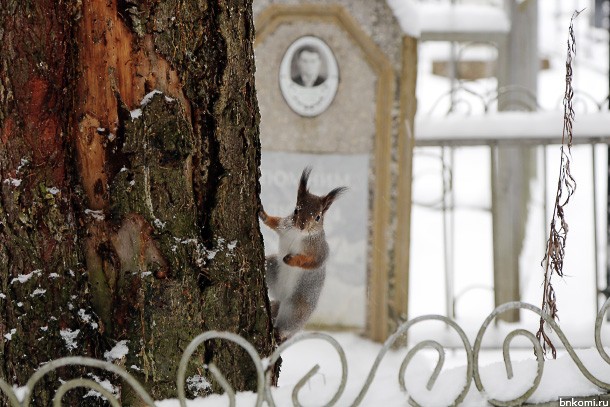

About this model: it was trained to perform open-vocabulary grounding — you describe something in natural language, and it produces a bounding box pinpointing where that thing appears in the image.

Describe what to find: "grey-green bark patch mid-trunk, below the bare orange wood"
[109,92,197,276]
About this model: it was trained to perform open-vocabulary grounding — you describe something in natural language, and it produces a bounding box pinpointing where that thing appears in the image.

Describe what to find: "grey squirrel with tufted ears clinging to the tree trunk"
[259,167,347,340]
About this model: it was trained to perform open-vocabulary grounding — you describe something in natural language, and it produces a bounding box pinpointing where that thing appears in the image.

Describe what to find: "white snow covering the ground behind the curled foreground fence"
[158,0,610,407]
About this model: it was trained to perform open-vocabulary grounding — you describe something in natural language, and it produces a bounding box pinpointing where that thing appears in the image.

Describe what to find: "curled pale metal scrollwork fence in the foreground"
[0,299,610,407]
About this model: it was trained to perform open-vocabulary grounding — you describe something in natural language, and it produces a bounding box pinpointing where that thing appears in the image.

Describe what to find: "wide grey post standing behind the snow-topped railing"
[492,0,539,322]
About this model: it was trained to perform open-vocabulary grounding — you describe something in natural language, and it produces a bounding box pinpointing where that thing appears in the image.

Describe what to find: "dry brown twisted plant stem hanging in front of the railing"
[536,10,582,359]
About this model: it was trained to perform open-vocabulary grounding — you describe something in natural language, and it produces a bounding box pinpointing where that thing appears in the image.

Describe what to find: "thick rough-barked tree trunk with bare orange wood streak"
[0,0,273,405]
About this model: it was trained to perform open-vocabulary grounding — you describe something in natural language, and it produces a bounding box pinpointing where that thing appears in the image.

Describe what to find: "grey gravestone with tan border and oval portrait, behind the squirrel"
[253,0,416,340]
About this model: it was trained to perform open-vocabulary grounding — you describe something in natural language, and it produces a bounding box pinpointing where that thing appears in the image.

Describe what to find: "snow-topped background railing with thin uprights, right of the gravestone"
[413,85,610,317]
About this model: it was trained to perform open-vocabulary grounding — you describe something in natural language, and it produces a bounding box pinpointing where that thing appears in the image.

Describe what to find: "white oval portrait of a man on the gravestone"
[279,35,339,117]
